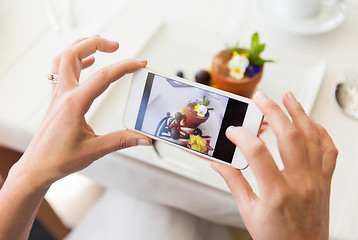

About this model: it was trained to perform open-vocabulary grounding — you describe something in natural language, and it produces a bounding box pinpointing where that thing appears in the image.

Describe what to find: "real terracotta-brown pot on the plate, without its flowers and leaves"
[211,50,264,98]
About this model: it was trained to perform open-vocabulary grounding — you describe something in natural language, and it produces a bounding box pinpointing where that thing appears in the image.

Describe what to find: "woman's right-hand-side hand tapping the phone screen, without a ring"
[212,92,338,240]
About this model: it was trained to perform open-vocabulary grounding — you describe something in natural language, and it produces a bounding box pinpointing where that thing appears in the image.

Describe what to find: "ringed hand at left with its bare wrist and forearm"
[0,36,151,239]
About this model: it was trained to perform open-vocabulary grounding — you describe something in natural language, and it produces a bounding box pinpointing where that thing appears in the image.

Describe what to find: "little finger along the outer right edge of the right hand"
[311,118,338,186]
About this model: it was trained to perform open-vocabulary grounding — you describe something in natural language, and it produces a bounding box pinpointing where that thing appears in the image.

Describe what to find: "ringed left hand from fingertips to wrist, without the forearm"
[15,36,151,187]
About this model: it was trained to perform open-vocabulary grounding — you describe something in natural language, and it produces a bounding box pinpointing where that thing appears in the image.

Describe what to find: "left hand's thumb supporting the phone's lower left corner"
[89,130,152,158]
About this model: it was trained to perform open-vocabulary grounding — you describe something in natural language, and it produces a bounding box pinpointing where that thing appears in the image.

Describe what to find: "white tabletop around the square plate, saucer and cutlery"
[0,0,358,239]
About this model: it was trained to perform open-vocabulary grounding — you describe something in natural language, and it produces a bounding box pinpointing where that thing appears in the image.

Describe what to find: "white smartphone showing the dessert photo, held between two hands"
[123,68,263,169]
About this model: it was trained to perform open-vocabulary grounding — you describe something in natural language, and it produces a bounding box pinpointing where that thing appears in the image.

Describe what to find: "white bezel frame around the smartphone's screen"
[123,68,263,169]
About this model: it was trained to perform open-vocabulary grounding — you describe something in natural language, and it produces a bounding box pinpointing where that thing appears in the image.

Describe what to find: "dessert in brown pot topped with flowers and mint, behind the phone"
[211,32,273,98]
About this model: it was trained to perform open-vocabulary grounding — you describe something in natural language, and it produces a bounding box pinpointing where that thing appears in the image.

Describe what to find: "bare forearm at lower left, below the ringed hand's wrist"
[0,162,48,240]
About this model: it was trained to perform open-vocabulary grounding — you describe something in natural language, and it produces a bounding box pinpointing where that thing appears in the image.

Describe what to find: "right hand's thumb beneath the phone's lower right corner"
[210,162,257,206]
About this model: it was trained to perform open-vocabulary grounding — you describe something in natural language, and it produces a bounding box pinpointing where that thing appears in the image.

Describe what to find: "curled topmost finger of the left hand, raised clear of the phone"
[59,37,118,86]
